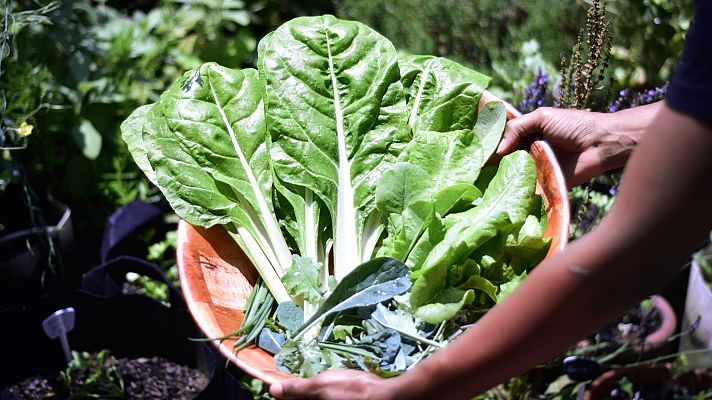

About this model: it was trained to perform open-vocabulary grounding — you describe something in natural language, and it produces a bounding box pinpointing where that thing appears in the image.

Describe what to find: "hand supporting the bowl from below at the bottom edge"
[270,369,393,400]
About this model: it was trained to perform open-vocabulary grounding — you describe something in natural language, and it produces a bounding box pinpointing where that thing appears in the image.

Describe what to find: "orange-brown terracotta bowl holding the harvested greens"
[177,93,569,384]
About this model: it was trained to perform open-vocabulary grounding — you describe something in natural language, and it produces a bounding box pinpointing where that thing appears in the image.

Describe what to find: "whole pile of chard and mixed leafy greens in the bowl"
[122,15,549,376]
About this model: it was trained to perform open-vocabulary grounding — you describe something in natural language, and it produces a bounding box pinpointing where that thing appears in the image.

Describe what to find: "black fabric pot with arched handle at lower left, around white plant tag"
[0,257,225,399]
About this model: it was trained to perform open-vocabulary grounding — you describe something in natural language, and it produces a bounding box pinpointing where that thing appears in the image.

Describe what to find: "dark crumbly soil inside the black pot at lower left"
[0,357,208,400]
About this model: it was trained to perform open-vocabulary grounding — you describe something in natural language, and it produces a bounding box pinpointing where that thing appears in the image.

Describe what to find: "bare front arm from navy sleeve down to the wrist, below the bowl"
[389,105,712,399]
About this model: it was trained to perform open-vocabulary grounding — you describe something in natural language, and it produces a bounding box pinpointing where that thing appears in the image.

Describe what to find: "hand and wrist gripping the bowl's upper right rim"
[497,104,657,187]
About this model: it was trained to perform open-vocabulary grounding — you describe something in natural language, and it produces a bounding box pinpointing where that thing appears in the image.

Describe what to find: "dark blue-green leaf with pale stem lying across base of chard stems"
[295,258,411,339]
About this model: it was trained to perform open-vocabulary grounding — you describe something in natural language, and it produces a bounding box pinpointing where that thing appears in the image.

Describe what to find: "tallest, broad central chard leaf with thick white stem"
[258,15,408,280]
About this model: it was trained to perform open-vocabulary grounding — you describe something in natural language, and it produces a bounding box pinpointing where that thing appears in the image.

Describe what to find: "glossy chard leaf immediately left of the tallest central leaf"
[159,64,292,253]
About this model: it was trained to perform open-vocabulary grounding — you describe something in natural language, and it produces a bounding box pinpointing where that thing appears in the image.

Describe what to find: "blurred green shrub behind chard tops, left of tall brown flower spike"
[334,0,585,88]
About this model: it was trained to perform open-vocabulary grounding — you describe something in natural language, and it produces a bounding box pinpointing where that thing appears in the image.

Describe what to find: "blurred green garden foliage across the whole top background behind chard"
[0,0,694,268]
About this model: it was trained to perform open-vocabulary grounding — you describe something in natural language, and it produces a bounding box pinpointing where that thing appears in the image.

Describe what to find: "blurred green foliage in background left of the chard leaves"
[0,0,331,284]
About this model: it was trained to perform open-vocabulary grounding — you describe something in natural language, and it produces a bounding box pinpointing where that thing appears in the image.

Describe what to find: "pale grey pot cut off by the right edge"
[680,260,712,368]
